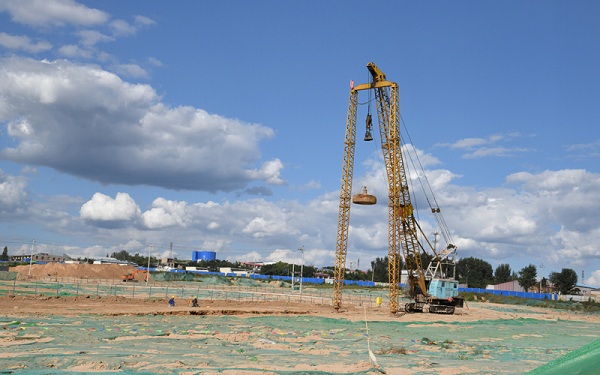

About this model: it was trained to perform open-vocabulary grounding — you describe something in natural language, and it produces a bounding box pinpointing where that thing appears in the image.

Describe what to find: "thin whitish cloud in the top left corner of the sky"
[0,0,109,27]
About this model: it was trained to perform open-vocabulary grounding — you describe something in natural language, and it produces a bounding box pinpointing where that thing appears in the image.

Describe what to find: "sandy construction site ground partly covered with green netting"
[0,265,600,375]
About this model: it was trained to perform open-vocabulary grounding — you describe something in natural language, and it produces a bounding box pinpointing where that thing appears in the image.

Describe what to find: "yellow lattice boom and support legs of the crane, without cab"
[333,62,462,314]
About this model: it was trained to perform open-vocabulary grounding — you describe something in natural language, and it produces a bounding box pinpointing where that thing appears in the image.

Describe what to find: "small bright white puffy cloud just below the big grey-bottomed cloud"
[79,193,140,221]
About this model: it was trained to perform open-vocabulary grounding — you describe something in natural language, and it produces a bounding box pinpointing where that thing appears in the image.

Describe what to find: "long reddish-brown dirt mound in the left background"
[10,263,137,279]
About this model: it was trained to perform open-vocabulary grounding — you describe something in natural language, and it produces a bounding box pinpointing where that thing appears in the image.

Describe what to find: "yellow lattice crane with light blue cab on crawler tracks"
[332,62,464,314]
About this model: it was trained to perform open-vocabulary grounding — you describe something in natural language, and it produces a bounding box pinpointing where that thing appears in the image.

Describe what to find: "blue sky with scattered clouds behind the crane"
[0,0,600,286]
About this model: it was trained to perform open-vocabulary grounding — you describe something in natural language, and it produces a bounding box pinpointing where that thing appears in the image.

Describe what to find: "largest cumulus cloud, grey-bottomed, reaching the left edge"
[0,57,285,192]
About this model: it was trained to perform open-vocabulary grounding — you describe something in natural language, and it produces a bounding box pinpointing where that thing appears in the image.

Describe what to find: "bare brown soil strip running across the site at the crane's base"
[0,296,600,323]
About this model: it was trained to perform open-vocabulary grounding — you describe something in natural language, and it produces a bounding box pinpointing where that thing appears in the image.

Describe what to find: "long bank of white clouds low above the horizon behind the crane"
[2,162,600,285]
